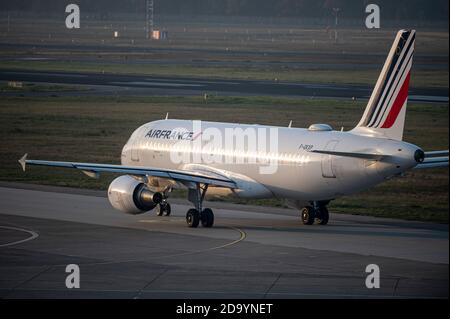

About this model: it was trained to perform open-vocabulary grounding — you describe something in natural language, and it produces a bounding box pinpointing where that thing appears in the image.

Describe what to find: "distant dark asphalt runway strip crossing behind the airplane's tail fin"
[0,70,448,102]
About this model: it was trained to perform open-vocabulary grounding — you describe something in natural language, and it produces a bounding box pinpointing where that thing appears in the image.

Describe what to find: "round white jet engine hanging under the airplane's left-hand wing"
[108,175,163,215]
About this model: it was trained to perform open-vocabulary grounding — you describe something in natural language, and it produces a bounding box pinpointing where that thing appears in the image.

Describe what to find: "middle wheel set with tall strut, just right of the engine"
[186,184,214,228]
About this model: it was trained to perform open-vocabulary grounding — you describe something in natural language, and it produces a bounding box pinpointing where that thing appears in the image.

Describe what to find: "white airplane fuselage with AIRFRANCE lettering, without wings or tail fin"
[121,120,419,201]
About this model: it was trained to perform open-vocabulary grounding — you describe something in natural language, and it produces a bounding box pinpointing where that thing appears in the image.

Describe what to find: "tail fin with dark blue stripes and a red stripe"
[353,30,416,140]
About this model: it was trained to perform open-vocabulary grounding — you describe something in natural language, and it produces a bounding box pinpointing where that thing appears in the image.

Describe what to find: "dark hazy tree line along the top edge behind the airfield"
[0,0,449,20]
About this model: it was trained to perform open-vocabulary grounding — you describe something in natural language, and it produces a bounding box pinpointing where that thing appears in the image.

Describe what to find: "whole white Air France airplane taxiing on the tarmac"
[19,30,449,227]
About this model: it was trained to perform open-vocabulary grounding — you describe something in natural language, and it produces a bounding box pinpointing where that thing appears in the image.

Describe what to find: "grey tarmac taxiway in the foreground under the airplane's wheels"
[0,183,449,298]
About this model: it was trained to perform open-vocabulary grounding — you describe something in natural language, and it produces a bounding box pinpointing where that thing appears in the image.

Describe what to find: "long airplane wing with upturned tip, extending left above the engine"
[19,154,237,189]
